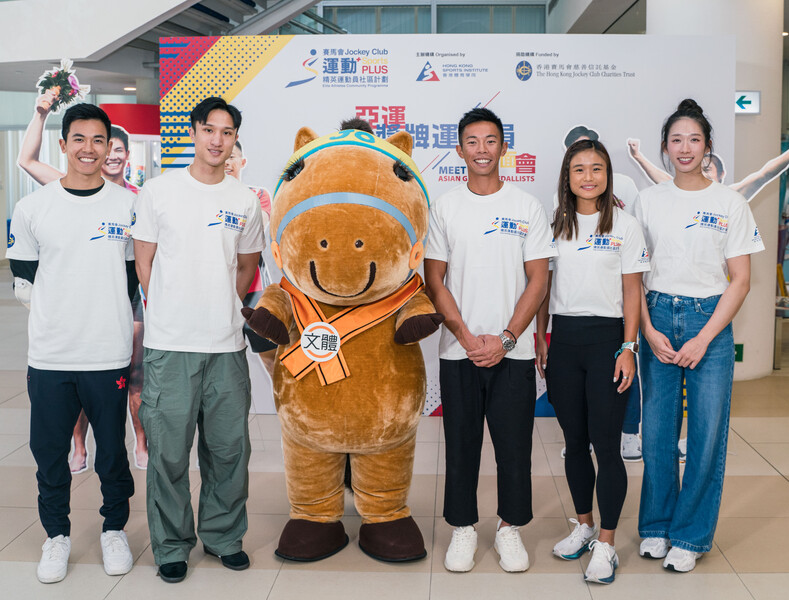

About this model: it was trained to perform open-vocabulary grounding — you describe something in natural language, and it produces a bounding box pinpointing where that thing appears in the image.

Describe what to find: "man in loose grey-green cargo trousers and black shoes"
[132,98,264,583]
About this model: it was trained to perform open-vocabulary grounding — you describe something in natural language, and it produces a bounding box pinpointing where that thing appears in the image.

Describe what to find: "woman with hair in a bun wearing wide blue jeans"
[635,100,764,572]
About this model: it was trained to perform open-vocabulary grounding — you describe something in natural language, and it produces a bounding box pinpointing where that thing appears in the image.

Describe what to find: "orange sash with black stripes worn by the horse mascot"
[279,275,425,385]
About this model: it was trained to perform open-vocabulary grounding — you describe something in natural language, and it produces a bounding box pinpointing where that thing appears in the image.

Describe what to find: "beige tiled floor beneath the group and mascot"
[0,268,789,600]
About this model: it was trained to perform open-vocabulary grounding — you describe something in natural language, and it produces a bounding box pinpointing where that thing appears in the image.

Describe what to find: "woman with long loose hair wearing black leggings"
[537,140,649,583]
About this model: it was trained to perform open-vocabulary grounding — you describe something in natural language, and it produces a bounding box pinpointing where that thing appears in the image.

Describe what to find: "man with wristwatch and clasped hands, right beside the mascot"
[425,108,556,572]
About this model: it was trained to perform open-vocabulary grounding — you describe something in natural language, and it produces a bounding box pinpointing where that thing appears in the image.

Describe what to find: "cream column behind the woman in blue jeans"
[647,0,783,380]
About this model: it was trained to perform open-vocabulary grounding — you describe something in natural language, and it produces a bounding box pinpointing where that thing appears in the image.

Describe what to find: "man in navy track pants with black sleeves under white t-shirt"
[6,104,137,583]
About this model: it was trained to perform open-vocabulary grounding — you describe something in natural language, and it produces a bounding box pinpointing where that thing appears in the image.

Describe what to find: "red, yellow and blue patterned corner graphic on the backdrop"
[160,35,293,170]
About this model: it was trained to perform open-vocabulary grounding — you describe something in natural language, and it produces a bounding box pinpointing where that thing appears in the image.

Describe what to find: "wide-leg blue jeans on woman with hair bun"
[638,292,734,552]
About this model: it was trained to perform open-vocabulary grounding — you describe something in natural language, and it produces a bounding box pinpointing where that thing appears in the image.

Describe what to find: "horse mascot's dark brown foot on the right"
[359,517,427,562]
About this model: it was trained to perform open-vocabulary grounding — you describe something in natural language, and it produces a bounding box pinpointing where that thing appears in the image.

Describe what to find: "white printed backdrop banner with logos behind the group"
[160,35,735,414]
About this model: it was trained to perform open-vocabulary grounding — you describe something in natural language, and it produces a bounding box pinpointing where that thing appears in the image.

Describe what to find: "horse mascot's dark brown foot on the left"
[274,519,348,562]
